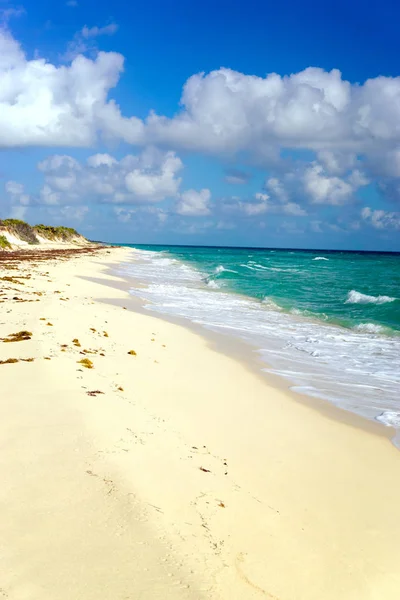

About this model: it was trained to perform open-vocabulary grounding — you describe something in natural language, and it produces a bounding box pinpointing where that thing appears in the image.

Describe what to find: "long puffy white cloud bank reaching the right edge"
[133,67,400,163]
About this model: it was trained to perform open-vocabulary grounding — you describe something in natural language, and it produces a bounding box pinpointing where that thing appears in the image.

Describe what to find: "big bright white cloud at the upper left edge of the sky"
[0,29,141,148]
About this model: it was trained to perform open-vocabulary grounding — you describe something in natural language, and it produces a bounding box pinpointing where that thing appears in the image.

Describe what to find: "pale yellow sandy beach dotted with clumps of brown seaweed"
[0,248,400,600]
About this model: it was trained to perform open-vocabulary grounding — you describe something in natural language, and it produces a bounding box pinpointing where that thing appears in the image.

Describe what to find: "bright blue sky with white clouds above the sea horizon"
[0,0,400,250]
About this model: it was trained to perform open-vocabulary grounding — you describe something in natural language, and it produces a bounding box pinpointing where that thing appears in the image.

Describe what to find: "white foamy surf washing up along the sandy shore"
[121,251,400,436]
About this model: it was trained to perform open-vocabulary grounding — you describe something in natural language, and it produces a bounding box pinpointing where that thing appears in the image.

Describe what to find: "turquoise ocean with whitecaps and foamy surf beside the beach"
[119,246,400,443]
